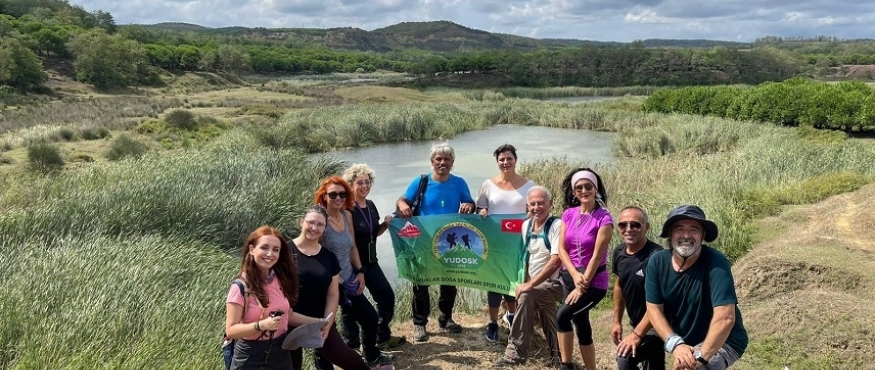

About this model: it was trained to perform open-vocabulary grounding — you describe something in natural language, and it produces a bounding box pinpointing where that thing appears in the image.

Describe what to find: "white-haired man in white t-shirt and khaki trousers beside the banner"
[497,186,563,366]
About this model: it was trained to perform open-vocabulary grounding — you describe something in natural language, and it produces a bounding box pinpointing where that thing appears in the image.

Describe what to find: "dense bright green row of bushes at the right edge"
[644,78,875,132]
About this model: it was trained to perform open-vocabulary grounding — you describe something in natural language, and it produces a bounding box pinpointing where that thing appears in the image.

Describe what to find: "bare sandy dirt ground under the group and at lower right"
[380,184,875,370]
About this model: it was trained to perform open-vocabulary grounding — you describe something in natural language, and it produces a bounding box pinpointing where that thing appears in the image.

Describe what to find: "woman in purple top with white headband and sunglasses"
[556,168,614,369]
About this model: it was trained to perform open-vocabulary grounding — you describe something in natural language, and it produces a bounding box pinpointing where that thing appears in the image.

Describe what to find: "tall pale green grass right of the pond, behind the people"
[521,116,875,260]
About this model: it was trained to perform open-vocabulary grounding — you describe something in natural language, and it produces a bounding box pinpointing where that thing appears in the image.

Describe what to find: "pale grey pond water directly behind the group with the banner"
[326,125,616,282]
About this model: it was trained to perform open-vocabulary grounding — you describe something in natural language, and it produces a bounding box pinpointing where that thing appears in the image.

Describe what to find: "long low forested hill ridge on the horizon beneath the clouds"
[142,21,751,52]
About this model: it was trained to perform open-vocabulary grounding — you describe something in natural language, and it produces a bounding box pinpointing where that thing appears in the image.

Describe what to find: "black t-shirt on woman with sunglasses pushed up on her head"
[289,243,340,317]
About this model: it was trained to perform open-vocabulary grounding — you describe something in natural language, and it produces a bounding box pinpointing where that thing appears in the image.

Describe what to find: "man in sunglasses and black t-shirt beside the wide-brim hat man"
[611,206,665,370]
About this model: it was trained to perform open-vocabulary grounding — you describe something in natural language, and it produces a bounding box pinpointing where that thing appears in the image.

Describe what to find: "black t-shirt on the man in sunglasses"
[611,240,662,327]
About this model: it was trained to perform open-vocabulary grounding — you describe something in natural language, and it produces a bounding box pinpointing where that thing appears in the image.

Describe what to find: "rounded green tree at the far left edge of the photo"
[0,37,48,89]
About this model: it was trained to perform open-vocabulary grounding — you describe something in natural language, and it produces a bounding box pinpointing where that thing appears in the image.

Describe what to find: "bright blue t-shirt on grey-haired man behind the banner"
[404,174,474,216]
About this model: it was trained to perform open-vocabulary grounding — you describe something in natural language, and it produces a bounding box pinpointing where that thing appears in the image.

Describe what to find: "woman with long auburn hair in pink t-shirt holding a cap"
[225,226,328,370]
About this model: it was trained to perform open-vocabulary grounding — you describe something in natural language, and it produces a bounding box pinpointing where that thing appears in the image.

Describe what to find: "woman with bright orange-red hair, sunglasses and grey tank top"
[313,176,392,368]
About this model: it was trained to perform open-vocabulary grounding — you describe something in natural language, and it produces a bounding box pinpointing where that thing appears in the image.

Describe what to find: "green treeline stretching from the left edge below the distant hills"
[0,0,875,95]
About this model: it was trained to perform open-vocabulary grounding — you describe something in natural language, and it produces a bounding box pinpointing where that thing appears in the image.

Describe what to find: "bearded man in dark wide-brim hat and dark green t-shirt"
[644,205,748,370]
